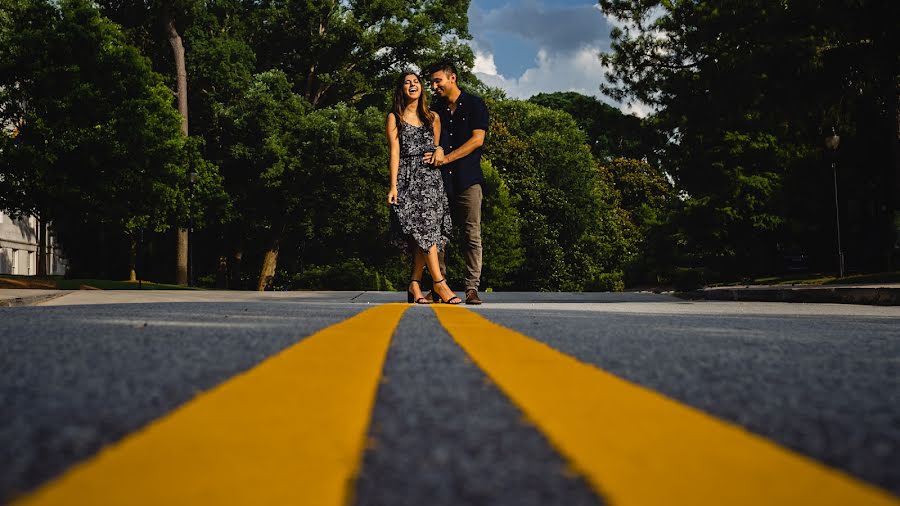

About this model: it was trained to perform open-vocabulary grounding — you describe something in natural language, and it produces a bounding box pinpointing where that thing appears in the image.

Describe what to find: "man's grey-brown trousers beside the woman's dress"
[438,184,482,290]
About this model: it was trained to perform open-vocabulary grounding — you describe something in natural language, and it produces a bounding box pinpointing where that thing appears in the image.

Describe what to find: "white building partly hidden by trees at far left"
[0,211,67,276]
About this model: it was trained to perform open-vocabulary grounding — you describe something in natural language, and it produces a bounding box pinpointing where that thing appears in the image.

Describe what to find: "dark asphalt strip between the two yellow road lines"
[355,307,602,506]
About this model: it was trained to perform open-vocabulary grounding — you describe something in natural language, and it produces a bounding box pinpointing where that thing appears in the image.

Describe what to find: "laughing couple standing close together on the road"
[386,64,488,304]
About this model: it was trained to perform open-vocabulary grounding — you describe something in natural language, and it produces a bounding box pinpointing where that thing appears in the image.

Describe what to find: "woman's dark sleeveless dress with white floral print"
[390,118,451,253]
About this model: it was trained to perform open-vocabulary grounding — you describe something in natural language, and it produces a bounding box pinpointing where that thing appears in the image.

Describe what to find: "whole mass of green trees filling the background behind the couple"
[14,0,900,290]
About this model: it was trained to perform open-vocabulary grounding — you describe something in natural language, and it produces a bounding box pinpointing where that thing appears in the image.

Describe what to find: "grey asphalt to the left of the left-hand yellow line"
[0,302,366,503]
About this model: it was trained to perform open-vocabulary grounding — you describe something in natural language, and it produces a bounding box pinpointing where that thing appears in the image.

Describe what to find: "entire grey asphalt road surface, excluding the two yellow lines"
[0,293,900,505]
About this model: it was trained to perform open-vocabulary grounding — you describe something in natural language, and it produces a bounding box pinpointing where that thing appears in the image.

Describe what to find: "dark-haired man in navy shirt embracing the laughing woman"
[427,63,489,304]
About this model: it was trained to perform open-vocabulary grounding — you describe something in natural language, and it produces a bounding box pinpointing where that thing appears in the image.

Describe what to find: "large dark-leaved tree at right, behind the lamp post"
[600,0,900,273]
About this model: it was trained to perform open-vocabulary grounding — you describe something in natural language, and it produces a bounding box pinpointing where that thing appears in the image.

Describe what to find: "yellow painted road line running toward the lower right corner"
[434,306,900,506]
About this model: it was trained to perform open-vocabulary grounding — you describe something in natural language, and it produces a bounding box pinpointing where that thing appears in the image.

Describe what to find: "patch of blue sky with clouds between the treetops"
[469,0,645,114]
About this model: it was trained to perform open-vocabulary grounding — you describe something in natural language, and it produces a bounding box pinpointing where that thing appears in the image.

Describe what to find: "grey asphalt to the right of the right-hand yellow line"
[477,305,900,494]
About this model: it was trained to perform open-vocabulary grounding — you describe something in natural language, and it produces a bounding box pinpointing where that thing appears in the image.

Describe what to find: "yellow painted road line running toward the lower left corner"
[16,304,409,506]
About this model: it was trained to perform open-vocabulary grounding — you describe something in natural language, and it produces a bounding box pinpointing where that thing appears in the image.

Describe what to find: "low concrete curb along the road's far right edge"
[674,287,900,306]
